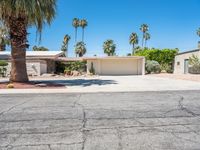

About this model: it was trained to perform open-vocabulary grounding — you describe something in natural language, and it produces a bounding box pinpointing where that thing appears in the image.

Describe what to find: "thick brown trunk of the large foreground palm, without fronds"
[9,16,28,82]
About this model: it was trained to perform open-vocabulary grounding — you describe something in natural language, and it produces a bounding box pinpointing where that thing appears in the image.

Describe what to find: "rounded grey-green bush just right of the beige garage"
[146,60,161,74]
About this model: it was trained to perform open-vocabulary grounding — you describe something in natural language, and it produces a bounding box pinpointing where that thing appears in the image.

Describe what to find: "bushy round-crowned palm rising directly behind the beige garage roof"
[103,40,116,56]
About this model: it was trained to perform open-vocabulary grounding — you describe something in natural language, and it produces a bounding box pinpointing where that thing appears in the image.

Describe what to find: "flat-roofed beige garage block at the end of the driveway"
[86,56,145,75]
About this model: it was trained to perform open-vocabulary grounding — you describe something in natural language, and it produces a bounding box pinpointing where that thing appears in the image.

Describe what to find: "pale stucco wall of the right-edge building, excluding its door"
[174,51,200,74]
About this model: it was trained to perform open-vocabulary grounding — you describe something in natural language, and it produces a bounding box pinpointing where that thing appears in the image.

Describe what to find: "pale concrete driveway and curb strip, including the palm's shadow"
[0,76,200,94]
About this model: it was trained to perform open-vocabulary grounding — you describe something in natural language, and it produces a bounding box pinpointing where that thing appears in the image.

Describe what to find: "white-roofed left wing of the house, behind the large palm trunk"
[0,51,64,76]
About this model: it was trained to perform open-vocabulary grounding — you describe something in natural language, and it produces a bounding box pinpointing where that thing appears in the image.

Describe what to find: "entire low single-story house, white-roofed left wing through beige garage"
[0,51,145,76]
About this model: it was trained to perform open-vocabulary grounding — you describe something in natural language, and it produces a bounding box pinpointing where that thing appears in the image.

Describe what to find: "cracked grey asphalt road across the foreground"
[0,91,200,150]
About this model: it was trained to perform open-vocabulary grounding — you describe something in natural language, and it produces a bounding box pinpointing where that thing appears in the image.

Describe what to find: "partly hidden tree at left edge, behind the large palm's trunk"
[0,24,10,51]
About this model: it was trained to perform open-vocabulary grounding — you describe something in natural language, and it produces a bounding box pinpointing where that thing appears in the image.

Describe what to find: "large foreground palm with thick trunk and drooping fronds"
[0,0,56,82]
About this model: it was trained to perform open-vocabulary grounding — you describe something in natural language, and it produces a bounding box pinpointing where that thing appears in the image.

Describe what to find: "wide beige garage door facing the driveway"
[101,59,138,75]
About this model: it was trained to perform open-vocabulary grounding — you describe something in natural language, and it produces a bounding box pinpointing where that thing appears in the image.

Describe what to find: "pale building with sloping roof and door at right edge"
[174,48,200,74]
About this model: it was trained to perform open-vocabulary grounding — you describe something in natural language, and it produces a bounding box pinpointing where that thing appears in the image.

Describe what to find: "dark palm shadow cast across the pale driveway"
[36,79,117,87]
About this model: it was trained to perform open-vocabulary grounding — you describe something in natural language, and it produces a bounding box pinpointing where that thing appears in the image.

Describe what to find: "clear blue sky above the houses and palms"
[29,0,200,56]
